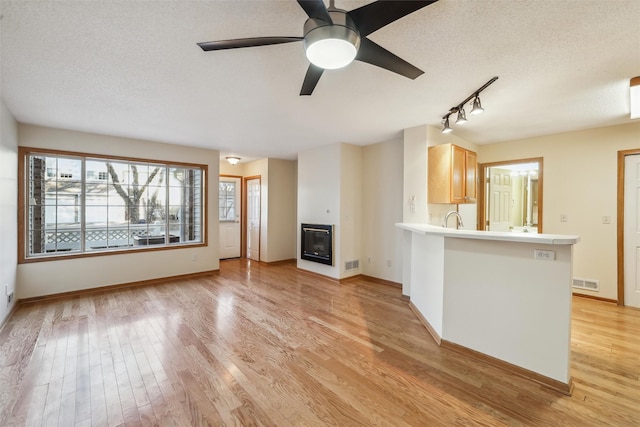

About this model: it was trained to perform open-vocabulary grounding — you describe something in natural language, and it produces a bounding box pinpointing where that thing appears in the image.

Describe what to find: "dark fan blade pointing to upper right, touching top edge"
[347,0,438,37]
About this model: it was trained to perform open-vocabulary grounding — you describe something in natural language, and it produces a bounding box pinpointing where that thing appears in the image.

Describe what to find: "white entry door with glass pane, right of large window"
[219,177,241,259]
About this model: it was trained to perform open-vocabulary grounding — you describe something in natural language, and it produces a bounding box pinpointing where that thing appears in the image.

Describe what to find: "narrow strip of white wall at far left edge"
[0,99,18,325]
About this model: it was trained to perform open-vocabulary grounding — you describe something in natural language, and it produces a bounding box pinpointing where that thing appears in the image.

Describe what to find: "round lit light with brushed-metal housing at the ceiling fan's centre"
[304,25,360,70]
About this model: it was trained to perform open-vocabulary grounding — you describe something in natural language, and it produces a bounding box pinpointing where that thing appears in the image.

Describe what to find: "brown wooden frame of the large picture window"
[18,147,209,264]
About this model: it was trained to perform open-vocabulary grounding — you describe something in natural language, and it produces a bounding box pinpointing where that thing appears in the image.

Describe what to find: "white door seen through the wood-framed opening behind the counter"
[486,168,512,231]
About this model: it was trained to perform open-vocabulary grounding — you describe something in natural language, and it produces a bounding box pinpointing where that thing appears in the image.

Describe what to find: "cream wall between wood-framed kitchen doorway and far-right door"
[478,121,640,299]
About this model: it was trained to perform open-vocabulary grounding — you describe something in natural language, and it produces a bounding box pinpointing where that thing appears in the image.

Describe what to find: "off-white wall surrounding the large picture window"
[16,124,219,298]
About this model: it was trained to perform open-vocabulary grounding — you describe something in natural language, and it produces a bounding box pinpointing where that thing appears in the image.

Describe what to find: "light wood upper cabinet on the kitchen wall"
[428,144,478,204]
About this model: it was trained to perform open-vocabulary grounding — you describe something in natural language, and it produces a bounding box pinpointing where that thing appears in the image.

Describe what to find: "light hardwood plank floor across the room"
[0,260,640,426]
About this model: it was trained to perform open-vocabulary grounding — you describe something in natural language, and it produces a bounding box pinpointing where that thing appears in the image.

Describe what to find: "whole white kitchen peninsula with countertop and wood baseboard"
[396,223,579,394]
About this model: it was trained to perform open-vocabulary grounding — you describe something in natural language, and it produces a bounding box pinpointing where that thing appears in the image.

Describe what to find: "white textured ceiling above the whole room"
[0,0,640,164]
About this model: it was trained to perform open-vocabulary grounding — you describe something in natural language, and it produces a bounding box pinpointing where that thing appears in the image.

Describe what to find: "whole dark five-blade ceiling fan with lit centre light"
[198,0,438,95]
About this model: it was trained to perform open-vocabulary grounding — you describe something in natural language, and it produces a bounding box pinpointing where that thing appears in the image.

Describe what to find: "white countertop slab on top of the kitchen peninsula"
[396,222,580,245]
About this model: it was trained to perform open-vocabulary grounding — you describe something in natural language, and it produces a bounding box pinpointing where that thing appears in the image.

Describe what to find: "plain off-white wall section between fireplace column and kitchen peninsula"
[361,141,404,283]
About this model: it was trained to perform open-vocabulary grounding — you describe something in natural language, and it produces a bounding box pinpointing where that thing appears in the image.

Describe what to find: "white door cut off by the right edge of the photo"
[624,155,640,308]
